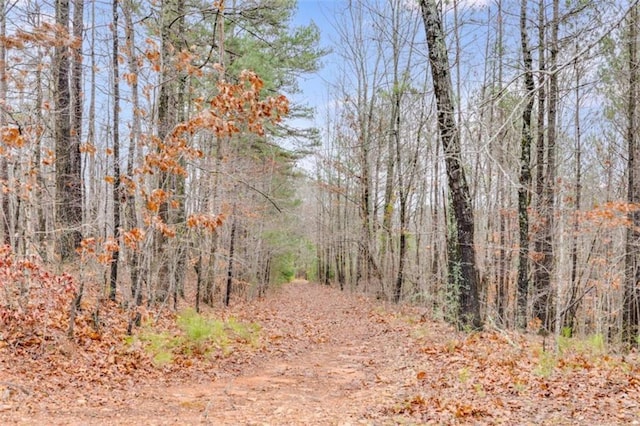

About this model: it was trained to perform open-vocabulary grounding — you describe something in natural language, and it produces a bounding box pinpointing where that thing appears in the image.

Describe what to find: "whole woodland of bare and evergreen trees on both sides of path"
[0,0,640,347]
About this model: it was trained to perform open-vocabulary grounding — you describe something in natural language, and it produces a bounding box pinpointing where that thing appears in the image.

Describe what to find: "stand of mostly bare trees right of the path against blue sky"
[316,0,637,340]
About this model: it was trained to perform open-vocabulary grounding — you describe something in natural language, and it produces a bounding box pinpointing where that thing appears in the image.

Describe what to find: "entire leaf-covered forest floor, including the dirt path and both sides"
[0,281,640,425]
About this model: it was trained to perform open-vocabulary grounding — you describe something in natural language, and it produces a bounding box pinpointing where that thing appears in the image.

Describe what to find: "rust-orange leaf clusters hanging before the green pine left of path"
[131,68,289,247]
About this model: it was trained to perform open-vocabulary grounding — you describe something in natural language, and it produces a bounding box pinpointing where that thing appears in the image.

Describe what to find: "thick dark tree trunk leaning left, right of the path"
[420,0,482,327]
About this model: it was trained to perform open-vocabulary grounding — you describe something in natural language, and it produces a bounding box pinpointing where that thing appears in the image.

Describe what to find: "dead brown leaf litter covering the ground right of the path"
[395,331,640,424]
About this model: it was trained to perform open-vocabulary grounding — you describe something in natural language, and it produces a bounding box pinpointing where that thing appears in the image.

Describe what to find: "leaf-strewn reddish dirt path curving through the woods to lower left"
[0,282,424,425]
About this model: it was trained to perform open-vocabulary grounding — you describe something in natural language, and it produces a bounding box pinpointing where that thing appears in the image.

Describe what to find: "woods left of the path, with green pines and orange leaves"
[0,0,324,330]
